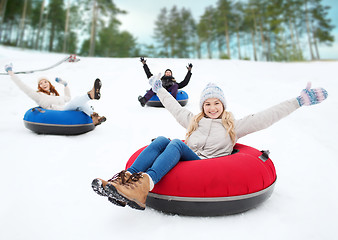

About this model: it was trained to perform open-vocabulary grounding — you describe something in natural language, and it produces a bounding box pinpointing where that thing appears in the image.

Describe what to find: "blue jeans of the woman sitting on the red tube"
[127,137,200,184]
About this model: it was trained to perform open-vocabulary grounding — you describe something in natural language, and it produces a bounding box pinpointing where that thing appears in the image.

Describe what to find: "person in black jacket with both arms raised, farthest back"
[138,57,192,107]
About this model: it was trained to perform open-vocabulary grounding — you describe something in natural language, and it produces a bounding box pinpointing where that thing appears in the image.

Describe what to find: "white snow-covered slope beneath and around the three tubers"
[0,46,338,240]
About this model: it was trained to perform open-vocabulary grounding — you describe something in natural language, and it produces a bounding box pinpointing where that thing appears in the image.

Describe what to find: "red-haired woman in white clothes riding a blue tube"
[5,64,106,126]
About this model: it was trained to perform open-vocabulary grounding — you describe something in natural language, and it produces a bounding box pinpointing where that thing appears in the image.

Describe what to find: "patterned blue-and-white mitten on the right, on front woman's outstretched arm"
[297,82,328,106]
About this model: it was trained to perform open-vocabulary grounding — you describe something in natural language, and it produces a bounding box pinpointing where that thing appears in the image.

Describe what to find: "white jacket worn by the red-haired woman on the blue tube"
[11,75,71,110]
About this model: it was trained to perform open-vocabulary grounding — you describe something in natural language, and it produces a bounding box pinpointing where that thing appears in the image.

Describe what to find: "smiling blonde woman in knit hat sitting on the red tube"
[92,75,327,210]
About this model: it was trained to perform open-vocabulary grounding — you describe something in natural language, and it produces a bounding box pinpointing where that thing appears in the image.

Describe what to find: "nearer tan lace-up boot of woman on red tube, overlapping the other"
[105,172,150,210]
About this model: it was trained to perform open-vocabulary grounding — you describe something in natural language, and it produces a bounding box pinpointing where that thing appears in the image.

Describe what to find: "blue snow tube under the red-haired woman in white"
[23,107,95,135]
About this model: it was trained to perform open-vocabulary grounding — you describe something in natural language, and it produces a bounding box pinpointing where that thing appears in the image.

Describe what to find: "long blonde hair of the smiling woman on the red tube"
[185,110,236,145]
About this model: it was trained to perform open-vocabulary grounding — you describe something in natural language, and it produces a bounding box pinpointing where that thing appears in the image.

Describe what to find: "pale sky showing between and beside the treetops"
[114,0,338,59]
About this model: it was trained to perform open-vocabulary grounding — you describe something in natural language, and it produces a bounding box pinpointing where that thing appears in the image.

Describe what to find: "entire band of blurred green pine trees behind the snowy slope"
[0,0,335,61]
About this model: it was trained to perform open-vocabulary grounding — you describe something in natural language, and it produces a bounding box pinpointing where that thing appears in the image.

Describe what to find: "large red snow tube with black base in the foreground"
[126,144,276,216]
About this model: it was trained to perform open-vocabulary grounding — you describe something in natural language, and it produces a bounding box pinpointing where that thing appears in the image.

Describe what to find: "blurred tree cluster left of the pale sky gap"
[0,0,138,57]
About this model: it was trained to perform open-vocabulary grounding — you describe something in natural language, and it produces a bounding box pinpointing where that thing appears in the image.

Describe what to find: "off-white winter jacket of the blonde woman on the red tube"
[157,88,300,158]
